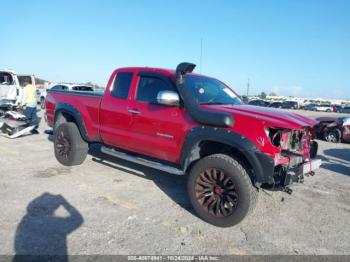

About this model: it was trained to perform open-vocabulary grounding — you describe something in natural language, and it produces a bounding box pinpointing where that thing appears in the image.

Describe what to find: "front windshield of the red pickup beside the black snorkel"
[185,75,242,105]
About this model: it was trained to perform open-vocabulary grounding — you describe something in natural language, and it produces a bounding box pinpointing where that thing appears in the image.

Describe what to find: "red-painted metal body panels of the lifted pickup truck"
[46,67,317,165]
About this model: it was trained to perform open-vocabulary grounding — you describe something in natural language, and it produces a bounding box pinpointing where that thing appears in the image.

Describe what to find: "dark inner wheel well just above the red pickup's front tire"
[186,140,254,183]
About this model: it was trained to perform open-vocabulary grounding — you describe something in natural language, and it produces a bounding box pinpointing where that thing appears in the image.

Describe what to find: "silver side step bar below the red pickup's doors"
[101,146,185,175]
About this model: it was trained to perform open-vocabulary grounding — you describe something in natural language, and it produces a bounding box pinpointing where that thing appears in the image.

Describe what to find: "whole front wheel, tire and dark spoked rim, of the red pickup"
[187,154,258,227]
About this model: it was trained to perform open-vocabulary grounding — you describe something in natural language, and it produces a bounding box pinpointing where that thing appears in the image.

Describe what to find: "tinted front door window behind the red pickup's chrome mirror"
[136,77,175,104]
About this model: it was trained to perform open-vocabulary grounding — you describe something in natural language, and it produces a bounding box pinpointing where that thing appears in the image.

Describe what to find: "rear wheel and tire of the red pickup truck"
[54,122,89,166]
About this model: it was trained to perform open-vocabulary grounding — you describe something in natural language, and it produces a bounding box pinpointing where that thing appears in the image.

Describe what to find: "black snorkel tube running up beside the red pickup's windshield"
[176,63,234,128]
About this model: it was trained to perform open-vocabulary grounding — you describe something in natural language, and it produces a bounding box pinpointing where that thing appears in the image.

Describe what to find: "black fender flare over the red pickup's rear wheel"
[54,103,91,142]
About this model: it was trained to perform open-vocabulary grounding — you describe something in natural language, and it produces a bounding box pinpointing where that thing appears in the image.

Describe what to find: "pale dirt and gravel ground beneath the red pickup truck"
[0,111,350,254]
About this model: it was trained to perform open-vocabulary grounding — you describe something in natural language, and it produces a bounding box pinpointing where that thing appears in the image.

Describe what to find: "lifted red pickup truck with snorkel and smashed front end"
[46,63,321,227]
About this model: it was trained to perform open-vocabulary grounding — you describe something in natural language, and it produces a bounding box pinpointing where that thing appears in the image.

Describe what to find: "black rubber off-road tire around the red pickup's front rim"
[187,154,258,227]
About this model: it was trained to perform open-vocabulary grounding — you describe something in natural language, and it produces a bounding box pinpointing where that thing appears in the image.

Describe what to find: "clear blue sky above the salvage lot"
[0,0,350,99]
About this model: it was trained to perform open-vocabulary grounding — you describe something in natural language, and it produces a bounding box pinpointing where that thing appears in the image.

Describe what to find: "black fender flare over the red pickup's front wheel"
[180,126,274,185]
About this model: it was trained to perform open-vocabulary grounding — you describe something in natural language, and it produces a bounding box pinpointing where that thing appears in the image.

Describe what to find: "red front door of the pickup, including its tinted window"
[129,76,185,162]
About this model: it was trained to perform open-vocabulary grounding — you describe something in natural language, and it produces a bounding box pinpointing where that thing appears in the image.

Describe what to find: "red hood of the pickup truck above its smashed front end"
[203,105,318,129]
